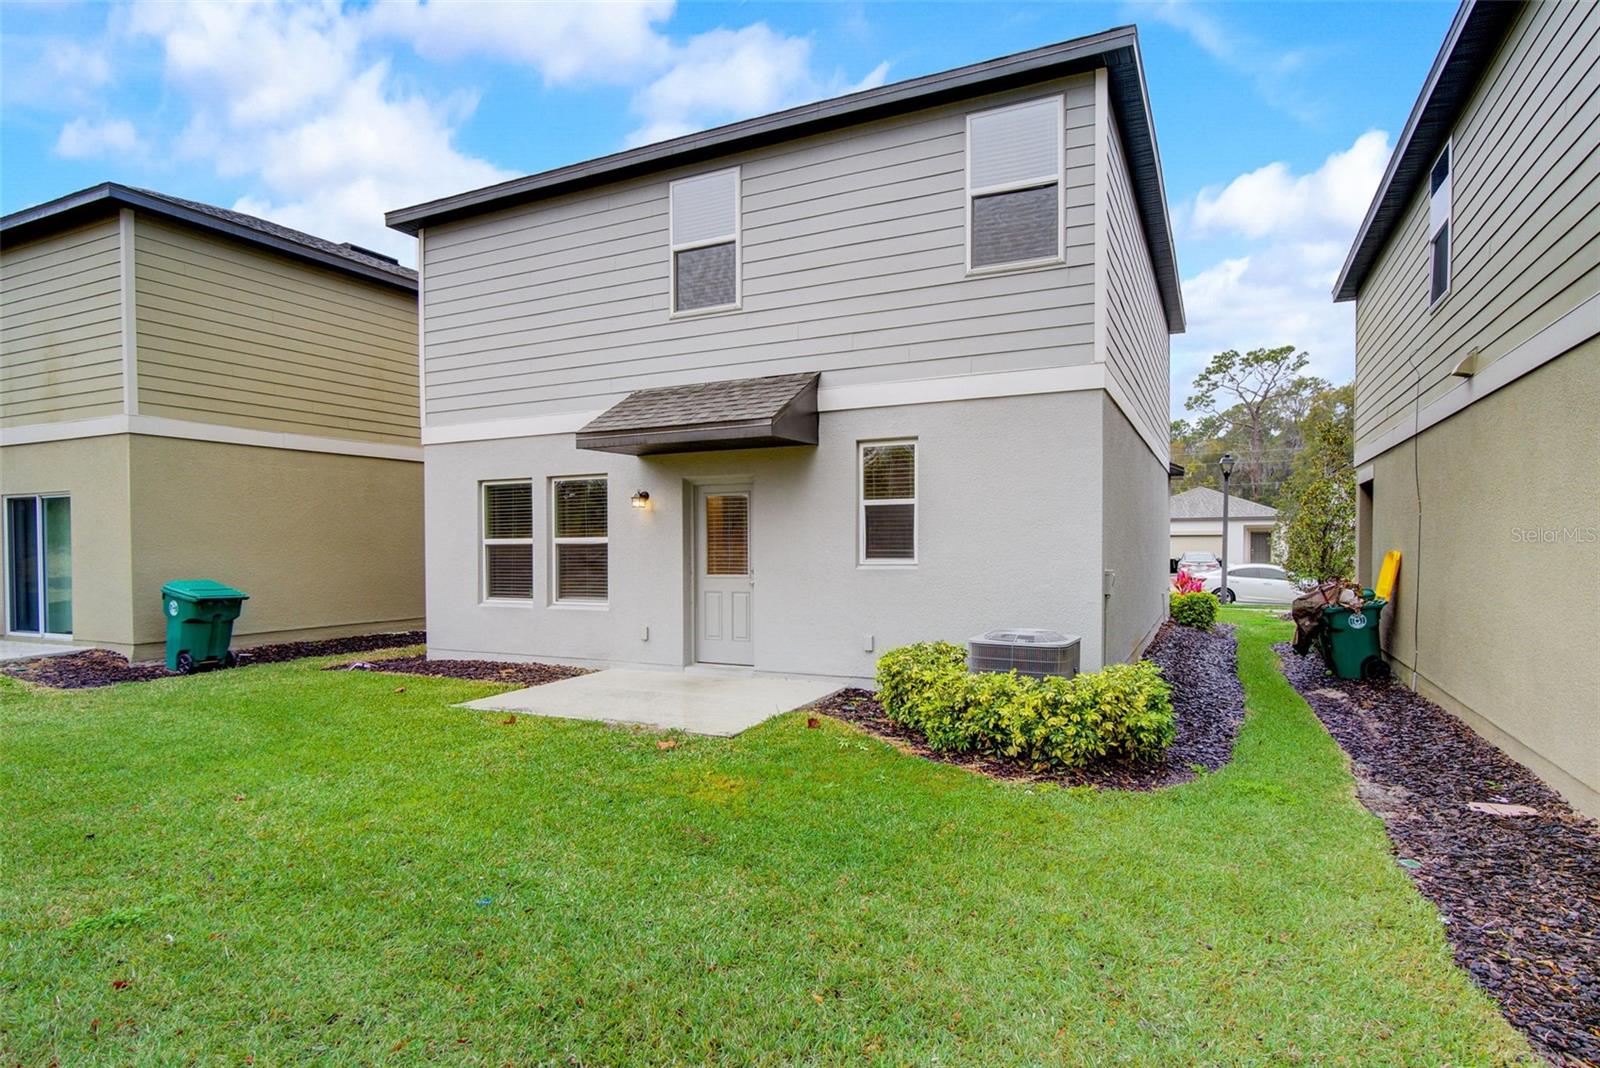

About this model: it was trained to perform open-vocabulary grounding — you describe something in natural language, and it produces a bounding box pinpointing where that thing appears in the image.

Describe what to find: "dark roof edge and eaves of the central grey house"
[386,26,1184,333]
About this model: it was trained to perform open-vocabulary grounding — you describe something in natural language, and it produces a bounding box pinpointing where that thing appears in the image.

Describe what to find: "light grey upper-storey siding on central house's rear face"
[424,77,1096,425]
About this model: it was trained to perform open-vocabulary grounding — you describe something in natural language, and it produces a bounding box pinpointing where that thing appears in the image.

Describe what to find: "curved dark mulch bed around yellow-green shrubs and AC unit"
[811,622,1245,790]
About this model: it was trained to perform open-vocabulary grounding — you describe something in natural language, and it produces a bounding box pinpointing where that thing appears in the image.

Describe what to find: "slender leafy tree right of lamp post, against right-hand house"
[1277,385,1355,582]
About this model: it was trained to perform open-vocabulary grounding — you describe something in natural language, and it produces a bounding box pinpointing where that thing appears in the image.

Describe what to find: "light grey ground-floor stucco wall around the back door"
[426,392,1120,678]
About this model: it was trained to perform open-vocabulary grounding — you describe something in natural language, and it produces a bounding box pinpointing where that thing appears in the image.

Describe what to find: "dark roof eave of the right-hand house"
[1333,0,1523,301]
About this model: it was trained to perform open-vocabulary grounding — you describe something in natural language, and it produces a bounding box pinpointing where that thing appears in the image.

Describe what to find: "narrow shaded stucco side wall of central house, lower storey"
[1101,395,1168,660]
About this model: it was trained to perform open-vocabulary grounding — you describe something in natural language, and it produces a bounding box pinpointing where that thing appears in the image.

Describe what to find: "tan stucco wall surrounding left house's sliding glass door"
[0,435,133,652]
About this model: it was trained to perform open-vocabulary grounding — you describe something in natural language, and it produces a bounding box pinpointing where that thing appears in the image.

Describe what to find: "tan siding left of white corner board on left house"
[0,217,122,427]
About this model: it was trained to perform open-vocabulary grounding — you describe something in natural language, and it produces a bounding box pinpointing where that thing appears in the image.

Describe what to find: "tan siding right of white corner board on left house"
[134,216,419,443]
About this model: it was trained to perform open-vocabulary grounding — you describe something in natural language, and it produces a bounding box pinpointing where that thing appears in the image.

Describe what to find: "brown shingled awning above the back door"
[578,371,819,456]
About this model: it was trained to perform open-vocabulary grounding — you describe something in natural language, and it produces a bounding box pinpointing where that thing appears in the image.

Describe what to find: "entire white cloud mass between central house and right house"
[1173,131,1389,411]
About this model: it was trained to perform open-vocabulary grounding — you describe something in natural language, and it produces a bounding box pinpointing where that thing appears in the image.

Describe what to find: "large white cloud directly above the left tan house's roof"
[131,3,512,261]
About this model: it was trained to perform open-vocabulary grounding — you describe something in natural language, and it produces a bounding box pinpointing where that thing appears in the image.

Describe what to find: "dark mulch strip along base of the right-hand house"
[1278,644,1600,1065]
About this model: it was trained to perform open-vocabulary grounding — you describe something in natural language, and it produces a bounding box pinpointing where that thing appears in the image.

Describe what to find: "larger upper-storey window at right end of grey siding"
[966,94,1067,272]
